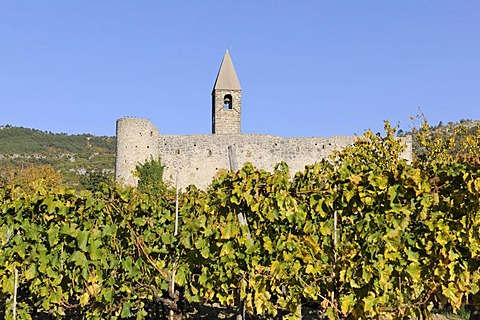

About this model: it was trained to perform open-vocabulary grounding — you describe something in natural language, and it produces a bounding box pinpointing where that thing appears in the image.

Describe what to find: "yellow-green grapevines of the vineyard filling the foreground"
[0,122,480,319]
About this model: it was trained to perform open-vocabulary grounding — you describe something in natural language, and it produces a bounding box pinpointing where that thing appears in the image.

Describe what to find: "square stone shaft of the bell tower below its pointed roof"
[212,89,242,134]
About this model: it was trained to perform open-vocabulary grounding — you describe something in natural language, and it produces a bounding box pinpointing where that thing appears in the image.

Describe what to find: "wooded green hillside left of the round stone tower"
[0,125,115,187]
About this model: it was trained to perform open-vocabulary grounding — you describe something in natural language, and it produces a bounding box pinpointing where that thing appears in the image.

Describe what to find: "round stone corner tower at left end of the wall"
[115,118,159,185]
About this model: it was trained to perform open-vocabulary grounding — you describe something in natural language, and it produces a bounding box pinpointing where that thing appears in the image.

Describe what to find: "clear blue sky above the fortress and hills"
[0,0,480,137]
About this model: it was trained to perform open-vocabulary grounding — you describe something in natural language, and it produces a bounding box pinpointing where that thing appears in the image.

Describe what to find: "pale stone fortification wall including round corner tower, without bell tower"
[116,118,411,189]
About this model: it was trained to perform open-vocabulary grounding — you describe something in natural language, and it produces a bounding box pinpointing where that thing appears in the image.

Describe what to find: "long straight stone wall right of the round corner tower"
[159,134,355,189]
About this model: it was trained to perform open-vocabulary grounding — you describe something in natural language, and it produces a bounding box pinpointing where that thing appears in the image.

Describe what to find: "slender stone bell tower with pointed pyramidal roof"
[212,50,242,134]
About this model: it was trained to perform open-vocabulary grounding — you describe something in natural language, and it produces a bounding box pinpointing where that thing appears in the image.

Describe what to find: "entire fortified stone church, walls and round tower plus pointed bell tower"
[115,50,412,189]
